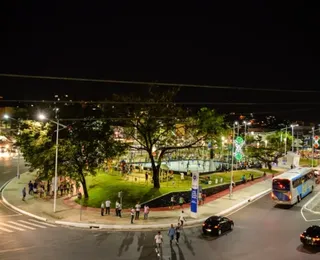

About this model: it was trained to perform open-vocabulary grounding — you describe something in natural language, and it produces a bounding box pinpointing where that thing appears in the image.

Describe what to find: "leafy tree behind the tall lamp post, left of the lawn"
[18,120,125,198]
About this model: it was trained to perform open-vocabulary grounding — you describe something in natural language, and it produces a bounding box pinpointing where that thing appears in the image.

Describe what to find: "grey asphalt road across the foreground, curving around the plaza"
[0,158,320,260]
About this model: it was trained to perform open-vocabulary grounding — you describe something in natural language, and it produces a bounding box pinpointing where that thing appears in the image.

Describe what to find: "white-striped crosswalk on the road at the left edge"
[0,219,57,234]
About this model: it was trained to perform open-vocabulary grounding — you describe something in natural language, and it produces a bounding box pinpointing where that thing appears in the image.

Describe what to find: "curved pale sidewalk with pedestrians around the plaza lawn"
[2,172,271,229]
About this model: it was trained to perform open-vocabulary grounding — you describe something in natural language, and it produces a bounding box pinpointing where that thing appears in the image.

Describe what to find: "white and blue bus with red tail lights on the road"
[271,167,316,205]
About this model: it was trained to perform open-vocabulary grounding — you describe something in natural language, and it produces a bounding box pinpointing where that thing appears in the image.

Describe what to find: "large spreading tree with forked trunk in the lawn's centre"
[109,88,224,188]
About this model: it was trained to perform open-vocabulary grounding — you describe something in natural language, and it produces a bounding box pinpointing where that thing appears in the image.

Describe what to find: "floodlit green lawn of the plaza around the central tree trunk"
[78,171,261,208]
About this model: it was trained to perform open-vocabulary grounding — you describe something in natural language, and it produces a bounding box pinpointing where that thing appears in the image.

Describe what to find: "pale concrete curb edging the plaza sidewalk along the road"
[54,189,271,231]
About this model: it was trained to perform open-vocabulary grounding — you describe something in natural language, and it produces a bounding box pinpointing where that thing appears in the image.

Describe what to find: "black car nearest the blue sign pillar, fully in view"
[202,216,234,236]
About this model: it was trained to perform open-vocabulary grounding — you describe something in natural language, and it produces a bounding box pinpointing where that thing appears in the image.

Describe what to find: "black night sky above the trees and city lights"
[0,0,320,119]
